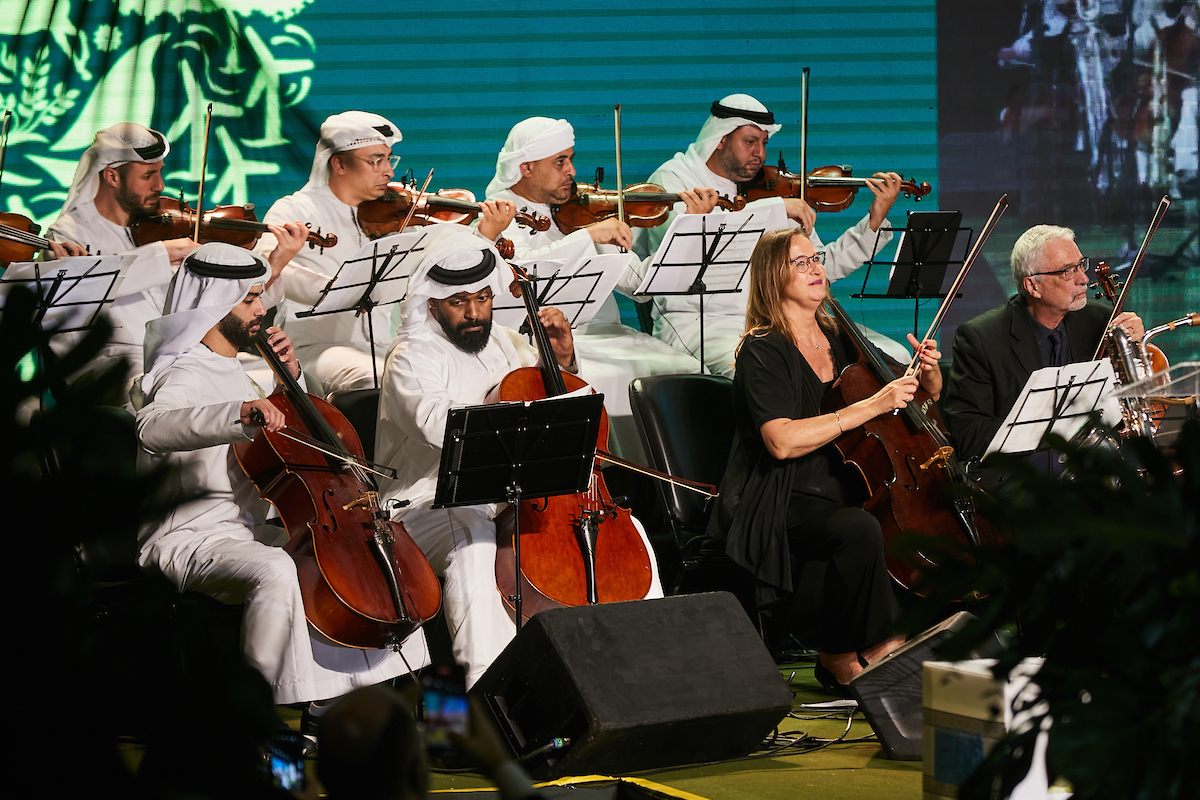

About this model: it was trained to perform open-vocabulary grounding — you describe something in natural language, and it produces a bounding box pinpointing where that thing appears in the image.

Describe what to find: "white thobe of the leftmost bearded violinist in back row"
[46,200,172,384]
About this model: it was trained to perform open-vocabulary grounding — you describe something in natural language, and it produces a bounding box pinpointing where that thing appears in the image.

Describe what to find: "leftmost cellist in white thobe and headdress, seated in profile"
[137,242,427,724]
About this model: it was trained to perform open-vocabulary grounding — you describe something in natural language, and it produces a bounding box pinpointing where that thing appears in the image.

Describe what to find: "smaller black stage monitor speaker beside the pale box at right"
[850,612,1000,762]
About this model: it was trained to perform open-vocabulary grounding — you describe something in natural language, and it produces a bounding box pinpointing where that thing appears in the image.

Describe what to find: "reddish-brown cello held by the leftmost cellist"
[234,329,442,650]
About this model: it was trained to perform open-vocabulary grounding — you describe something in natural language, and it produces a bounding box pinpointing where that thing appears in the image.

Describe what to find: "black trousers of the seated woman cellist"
[787,495,899,652]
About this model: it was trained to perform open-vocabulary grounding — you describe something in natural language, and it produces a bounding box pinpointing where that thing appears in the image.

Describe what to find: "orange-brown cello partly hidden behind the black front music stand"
[496,270,653,620]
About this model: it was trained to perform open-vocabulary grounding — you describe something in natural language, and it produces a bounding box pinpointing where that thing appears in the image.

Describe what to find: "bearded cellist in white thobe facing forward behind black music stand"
[374,225,662,686]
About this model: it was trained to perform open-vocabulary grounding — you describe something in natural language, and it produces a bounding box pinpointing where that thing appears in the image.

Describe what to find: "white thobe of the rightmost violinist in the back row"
[618,156,902,377]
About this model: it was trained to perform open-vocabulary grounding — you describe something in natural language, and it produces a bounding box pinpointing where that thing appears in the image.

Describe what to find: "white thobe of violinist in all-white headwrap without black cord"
[488,190,700,464]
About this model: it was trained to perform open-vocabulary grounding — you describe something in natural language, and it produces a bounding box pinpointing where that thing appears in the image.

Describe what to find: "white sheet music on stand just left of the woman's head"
[635,203,788,295]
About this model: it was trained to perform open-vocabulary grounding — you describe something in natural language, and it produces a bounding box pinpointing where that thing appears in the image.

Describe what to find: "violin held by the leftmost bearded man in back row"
[130,197,337,249]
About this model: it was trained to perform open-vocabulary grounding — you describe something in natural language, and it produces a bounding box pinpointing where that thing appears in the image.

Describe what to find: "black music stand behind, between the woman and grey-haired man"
[851,211,974,339]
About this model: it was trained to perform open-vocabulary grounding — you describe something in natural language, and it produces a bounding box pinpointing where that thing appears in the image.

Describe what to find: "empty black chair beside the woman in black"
[629,373,749,595]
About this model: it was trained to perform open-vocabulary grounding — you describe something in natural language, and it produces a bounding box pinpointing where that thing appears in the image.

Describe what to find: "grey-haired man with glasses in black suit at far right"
[942,225,1145,492]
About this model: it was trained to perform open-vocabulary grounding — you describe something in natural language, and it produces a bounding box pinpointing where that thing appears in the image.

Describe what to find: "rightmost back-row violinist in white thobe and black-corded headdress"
[634,95,905,375]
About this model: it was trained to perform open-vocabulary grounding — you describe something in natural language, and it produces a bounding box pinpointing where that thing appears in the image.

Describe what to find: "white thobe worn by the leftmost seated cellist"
[137,345,428,704]
